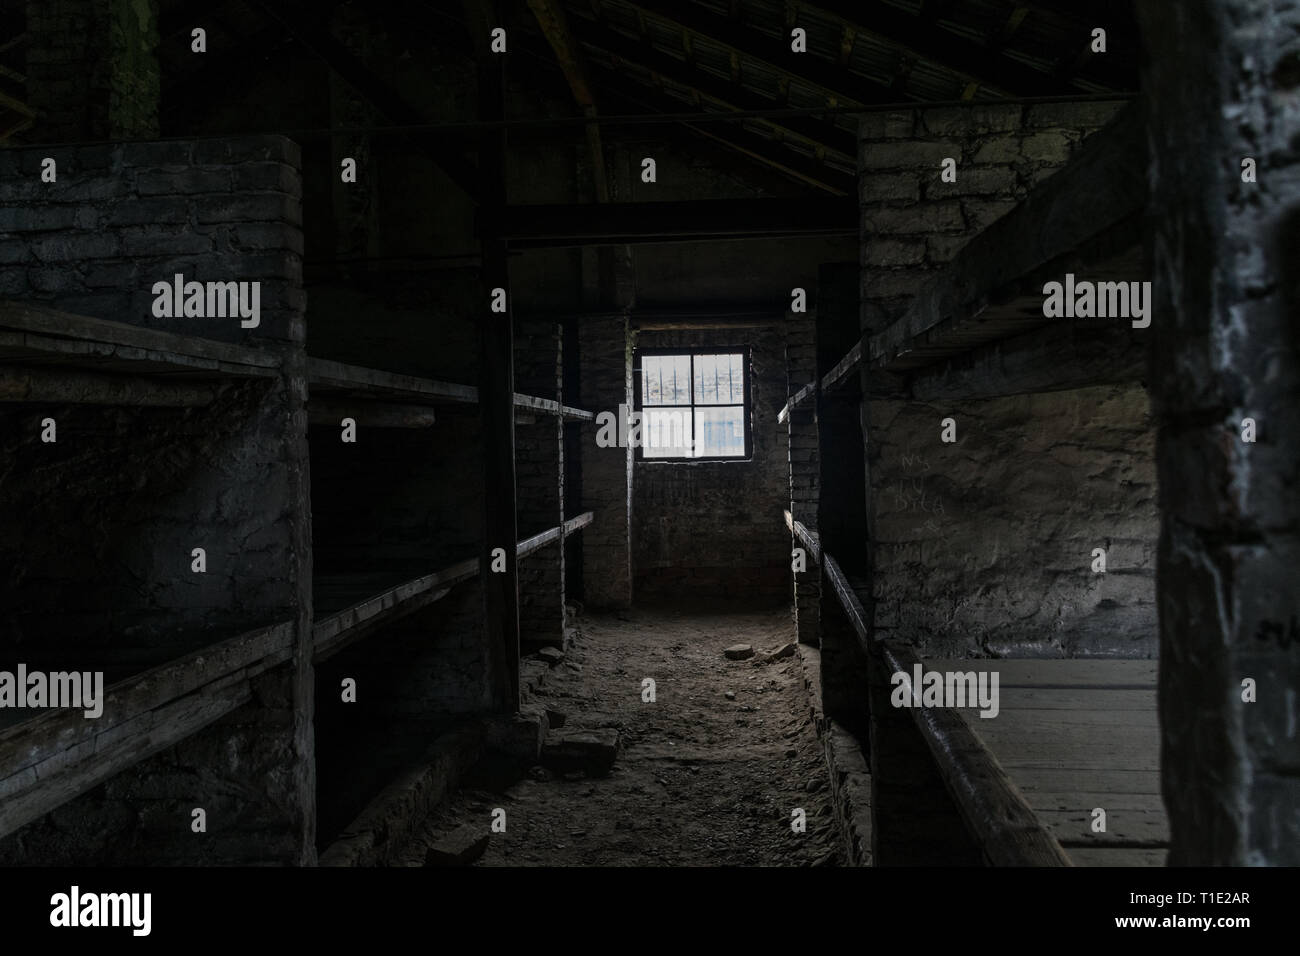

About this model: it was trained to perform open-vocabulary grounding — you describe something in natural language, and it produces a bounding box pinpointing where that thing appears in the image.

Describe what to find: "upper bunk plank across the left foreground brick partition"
[0,302,280,368]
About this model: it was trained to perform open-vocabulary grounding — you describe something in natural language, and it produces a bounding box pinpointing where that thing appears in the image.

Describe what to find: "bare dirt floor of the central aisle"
[411,609,841,866]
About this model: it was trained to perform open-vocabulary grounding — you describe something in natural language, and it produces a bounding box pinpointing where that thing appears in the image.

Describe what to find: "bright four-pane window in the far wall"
[634,349,750,460]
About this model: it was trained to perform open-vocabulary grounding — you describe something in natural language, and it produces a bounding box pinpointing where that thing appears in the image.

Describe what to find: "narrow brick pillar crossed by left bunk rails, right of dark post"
[515,320,564,648]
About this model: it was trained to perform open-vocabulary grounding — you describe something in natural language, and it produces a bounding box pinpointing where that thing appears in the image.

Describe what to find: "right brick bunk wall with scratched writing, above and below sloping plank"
[859,103,1157,657]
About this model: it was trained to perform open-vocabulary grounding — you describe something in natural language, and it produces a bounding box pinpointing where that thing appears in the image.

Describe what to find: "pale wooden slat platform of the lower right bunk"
[926,659,1169,866]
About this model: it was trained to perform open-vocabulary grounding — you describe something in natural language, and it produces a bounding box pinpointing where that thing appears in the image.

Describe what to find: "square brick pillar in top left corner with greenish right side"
[26,0,159,142]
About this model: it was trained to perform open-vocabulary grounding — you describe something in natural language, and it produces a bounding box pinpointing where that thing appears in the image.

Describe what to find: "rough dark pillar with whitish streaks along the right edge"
[1138,0,1300,866]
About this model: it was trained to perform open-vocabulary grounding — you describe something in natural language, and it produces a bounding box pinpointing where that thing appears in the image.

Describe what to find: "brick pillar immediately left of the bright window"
[579,315,632,607]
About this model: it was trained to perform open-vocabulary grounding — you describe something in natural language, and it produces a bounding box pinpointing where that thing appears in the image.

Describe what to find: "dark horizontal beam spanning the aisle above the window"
[502,199,858,248]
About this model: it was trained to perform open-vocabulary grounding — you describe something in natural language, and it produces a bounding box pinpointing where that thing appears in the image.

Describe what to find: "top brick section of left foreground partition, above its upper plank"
[0,137,306,342]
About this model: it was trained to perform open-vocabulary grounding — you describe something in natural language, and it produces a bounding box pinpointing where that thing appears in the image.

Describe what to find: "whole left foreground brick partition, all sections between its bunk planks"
[0,138,315,865]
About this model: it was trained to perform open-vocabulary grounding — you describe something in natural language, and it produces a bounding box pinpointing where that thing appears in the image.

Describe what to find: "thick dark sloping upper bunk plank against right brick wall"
[866,105,1147,368]
